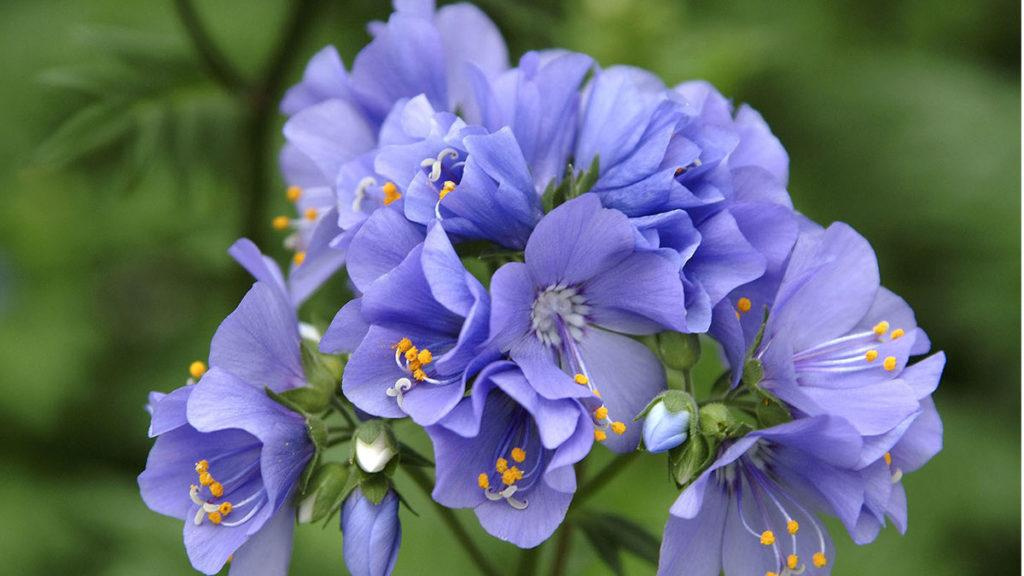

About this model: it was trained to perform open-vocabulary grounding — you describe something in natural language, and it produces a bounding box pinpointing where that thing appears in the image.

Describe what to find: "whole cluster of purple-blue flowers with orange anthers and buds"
[139,0,944,576]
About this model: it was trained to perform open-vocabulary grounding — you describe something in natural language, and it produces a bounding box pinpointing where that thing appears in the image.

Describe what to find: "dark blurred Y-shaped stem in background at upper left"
[174,0,317,287]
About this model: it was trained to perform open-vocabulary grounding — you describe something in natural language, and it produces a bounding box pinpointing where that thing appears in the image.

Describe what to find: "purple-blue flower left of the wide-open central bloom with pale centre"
[321,225,490,425]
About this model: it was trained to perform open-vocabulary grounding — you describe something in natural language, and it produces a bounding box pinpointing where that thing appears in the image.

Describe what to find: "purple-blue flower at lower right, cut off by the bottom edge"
[658,416,865,576]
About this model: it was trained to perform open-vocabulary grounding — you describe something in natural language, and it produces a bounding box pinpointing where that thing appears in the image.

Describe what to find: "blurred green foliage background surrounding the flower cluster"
[0,0,1021,575]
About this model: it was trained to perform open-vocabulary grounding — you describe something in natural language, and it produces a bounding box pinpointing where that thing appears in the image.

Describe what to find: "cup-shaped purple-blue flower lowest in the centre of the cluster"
[427,362,594,548]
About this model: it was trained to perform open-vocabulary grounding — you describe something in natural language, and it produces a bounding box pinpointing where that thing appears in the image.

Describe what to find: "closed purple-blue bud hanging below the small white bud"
[341,488,401,576]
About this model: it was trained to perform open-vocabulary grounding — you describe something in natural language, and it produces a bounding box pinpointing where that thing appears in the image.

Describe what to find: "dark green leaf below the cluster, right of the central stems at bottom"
[574,510,660,574]
